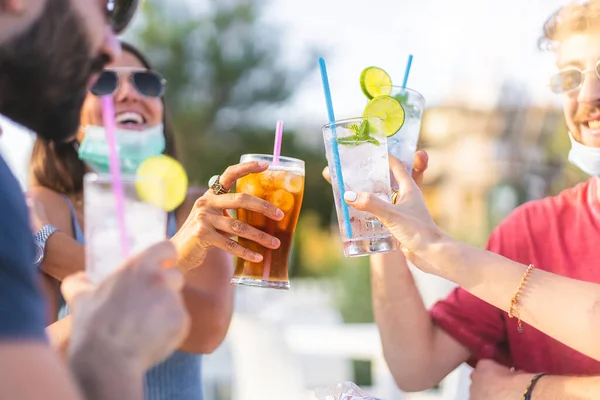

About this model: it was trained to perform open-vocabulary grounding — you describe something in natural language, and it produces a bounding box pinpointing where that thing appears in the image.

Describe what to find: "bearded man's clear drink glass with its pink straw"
[84,96,167,283]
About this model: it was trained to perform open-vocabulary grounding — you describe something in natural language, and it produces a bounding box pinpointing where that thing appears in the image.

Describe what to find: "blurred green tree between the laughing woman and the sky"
[128,0,332,225]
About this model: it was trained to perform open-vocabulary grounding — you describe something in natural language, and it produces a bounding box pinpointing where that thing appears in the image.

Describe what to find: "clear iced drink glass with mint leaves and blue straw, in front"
[322,118,396,257]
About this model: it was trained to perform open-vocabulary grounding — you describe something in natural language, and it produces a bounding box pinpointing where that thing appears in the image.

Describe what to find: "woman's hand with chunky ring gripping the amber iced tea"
[171,161,284,271]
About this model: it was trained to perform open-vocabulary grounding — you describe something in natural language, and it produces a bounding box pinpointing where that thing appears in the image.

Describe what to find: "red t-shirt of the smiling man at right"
[431,179,600,375]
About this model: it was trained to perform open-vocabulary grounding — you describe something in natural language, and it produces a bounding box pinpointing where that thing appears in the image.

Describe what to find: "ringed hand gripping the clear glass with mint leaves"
[344,156,445,272]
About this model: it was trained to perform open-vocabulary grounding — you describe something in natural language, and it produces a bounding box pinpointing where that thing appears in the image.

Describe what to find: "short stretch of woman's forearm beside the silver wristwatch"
[42,232,85,281]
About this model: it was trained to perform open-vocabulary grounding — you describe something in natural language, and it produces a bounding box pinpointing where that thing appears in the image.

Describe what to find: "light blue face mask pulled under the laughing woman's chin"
[78,124,166,174]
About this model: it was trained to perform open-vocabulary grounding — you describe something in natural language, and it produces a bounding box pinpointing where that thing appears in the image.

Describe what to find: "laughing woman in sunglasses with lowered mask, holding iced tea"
[29,43,283,400]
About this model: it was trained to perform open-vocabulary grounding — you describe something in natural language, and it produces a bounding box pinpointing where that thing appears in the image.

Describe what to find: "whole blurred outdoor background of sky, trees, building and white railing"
[0,0,585,400]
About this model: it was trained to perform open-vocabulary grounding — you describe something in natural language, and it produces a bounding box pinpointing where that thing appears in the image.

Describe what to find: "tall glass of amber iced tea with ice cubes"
[231,154,304,290]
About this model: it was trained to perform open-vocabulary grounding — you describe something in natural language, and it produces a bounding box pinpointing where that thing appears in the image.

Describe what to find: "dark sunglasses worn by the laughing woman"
[90,69,167,97]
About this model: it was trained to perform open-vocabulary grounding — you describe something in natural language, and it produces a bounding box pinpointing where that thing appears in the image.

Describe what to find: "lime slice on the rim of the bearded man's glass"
[136,155,188,211]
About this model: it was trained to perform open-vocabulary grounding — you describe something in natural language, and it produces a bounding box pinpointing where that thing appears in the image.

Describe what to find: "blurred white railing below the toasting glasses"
[204,276,470,400]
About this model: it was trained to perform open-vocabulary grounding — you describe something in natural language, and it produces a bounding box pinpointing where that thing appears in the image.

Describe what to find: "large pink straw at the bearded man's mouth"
[102,95,129,257]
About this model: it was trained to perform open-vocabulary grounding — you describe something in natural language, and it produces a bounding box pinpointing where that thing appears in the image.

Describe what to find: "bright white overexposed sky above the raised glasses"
[0,0,566,183]
